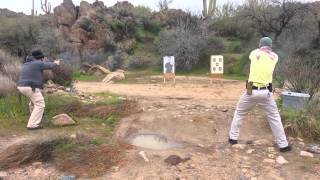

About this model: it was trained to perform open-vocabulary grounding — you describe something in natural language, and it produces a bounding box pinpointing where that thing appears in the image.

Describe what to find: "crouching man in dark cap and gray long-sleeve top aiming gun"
[18,50,60,130]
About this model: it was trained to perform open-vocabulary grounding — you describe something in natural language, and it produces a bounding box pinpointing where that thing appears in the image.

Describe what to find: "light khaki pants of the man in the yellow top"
[229,90,288,148]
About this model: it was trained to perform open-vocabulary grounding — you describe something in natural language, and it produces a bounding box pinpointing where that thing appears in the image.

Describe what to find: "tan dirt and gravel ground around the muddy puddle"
[0,77,320,180]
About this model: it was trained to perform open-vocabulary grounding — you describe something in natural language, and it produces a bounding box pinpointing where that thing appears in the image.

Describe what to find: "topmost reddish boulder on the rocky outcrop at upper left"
[53,0,78,27]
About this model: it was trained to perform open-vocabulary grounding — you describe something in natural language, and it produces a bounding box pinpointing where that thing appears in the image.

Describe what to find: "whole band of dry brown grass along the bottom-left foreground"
[0,138,128,178]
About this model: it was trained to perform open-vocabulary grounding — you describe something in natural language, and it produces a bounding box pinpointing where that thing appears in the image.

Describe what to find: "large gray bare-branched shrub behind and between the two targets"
[159,14,207,70]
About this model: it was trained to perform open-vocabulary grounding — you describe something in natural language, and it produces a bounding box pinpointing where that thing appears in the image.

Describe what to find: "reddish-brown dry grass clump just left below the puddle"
[54,144,125,178]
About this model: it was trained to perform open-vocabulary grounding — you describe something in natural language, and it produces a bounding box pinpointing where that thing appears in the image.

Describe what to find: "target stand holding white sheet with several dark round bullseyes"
[210,55,223,85]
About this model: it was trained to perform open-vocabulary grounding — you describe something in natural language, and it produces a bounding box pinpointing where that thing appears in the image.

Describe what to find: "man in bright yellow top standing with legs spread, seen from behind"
[229,37,292,152]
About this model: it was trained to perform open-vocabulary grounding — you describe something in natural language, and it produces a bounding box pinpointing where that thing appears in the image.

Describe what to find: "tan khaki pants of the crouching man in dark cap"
[18,87,45,128]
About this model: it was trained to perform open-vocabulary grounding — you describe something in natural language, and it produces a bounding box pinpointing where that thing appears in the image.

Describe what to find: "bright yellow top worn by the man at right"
[249,47,278,87]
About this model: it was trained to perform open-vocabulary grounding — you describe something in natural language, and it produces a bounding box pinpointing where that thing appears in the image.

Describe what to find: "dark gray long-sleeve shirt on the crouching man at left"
[18,57,57,88]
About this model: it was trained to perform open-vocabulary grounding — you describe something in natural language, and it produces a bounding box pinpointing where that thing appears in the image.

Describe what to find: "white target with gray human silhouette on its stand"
[163,56,176,84]
